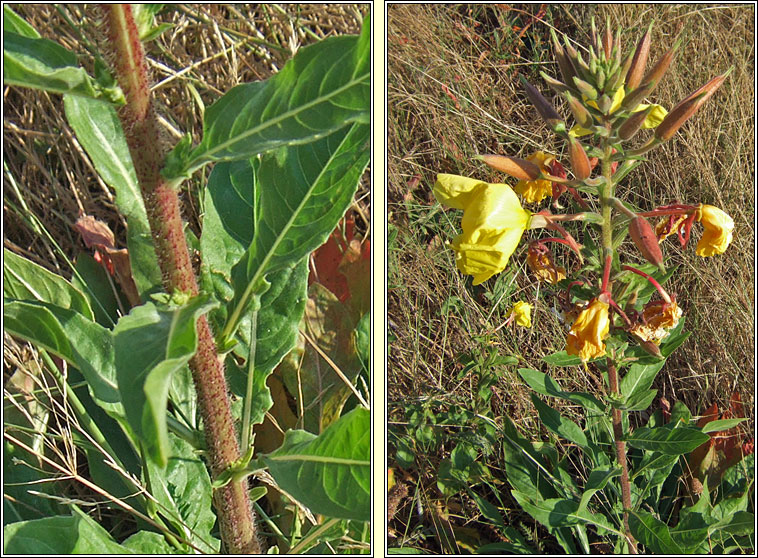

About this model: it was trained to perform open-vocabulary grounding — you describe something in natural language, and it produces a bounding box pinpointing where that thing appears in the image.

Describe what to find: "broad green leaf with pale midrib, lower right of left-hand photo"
[263,407,371,521]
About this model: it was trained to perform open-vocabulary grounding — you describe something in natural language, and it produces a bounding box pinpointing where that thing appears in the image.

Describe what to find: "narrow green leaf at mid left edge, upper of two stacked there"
[3,248,95,320]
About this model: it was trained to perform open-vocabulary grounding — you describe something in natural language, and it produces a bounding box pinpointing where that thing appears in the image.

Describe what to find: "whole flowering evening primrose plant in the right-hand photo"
[434,21,753,554]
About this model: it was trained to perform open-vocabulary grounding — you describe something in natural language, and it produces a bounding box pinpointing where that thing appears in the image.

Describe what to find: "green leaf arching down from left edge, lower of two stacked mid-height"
[3,300,121,411]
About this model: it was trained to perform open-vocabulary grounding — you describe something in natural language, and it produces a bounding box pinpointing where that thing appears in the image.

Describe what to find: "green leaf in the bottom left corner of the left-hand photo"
[3,506,133,556]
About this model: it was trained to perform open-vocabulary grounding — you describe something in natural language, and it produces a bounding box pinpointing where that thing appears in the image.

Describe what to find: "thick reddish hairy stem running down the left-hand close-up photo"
[101,4,263,554]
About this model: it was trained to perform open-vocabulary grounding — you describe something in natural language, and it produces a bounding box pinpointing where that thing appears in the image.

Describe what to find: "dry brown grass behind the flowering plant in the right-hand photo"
[387,4,755,556]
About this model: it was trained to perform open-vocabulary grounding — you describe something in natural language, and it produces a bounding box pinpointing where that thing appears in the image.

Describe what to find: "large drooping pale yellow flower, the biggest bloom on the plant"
[434,174,532,285]
